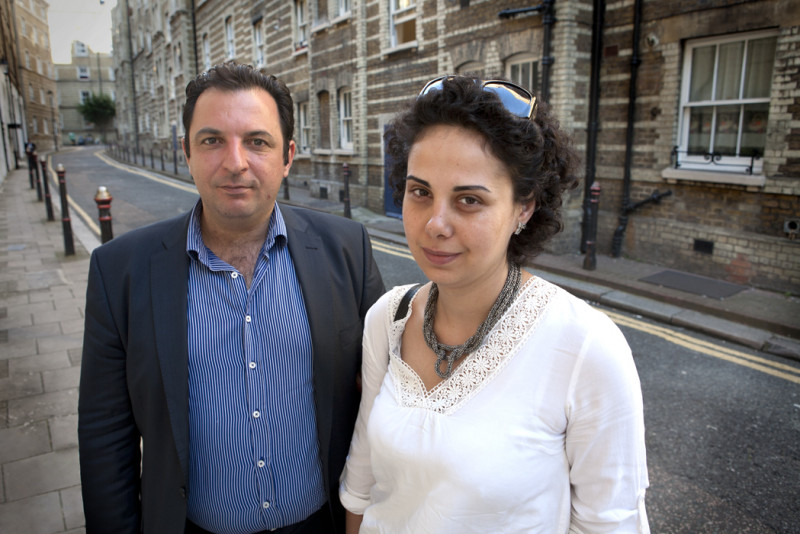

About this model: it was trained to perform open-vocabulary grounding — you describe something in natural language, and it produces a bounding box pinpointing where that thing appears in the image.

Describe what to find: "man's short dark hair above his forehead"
[183,62,294,163]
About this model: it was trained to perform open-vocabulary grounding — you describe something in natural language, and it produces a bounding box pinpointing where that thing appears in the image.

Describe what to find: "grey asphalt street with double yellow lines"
[52,147,800,533]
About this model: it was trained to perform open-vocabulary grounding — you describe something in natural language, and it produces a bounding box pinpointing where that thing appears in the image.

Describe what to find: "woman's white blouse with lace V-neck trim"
[339,277,649,534]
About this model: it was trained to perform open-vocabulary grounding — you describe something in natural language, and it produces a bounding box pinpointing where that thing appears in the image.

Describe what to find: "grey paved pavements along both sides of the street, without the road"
[0,153,800,534]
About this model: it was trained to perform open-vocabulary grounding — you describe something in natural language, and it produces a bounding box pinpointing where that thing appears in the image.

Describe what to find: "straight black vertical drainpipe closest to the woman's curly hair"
[581,0,606,253]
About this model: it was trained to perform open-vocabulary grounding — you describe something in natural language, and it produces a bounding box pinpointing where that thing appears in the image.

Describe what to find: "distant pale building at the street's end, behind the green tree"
[54,41,116,146]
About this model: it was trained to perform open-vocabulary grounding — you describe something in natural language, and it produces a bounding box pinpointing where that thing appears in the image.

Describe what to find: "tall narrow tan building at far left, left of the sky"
[14,0,59,152]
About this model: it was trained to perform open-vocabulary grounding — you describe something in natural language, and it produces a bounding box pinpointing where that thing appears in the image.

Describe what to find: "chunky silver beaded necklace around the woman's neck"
[422,263,522,378]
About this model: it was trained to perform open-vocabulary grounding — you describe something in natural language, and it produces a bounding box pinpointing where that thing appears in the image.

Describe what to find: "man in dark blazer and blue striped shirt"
[78,65,384,534]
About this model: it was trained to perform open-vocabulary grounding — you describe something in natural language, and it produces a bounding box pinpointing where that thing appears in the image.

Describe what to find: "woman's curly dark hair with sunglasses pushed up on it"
[386,76,579,265]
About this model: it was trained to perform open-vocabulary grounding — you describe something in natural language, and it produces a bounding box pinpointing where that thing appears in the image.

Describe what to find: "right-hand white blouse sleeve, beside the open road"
[566,310,650,534]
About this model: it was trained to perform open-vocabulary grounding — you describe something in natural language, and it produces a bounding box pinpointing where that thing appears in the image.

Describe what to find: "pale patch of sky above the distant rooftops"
[47,0,117,63]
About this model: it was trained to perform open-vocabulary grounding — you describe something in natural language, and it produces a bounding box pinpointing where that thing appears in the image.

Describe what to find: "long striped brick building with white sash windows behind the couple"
[114,0,800,293]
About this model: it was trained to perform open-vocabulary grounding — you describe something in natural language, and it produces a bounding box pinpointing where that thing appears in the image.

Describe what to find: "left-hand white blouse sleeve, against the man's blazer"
[339,288,397,515]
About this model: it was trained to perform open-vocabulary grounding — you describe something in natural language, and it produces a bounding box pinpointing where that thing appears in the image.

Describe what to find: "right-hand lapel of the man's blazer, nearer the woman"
[281,206,338,488]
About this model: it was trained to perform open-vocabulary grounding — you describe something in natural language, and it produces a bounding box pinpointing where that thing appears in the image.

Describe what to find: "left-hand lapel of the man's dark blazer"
[150,216,189,481]
